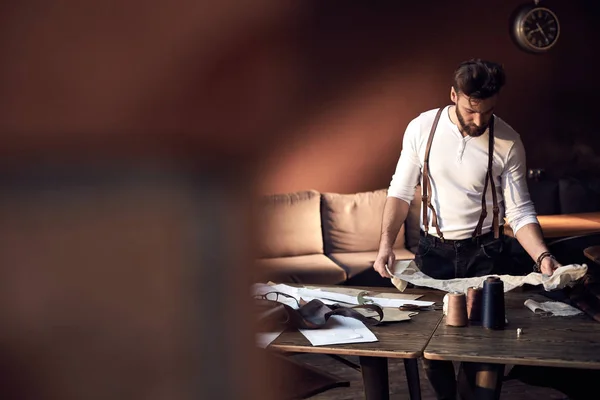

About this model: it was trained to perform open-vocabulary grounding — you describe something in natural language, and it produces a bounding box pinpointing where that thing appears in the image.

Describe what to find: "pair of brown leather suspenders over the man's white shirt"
[421,107,500,240]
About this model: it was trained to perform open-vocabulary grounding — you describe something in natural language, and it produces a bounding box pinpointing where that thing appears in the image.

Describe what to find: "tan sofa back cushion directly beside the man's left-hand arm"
[321,189,404,254]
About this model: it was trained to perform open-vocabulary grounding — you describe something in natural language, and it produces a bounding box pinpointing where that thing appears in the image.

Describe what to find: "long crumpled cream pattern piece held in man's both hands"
[388,260,587,294]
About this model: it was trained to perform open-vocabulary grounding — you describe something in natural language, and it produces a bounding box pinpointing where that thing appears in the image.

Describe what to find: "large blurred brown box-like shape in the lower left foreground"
[0,168,276,399]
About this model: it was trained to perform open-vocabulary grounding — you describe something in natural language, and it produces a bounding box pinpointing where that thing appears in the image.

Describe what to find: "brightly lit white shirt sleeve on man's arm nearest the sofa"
[388,118,421,204]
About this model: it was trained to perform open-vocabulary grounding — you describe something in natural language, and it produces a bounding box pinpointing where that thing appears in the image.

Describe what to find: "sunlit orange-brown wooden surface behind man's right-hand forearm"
[504,212,600,238]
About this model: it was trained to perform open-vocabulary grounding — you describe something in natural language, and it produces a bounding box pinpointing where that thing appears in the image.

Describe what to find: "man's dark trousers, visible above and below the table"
[415,232,512,400]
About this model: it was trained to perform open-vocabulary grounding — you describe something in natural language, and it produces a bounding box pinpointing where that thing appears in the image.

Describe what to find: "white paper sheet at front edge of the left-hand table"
[298,315,378,346]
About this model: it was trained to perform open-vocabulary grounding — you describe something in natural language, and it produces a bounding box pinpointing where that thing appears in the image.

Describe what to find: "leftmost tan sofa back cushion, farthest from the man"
[257,190,323,258]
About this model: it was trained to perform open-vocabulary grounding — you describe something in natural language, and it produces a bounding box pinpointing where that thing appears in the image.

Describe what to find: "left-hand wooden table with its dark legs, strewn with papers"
[268,288,443,400]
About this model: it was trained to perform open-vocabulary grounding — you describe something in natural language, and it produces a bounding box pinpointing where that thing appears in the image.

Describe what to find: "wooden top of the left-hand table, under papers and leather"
[269,288,444,358]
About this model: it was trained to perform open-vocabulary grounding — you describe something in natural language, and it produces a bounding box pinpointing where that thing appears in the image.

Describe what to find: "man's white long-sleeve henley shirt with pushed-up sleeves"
[388,107,539,240]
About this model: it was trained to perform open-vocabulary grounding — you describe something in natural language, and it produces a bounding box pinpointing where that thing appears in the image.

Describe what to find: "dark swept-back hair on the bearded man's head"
[452,58,506,100]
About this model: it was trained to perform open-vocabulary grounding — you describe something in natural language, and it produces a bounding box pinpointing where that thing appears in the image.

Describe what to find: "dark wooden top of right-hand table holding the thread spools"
[424,291,600,369]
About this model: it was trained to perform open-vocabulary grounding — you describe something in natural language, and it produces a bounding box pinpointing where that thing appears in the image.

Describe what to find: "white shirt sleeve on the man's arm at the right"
[502,138,539,234]
